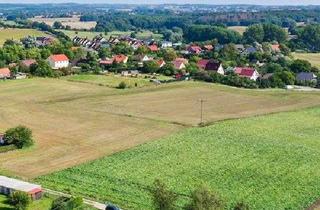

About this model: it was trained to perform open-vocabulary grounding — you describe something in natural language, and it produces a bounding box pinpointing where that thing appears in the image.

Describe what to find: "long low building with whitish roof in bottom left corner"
[0,176,42,200]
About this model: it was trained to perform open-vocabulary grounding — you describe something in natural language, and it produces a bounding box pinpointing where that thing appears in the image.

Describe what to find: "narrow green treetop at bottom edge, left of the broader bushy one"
[152,179,177,210]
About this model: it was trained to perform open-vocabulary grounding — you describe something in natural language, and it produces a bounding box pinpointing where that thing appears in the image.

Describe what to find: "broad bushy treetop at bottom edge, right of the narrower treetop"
[186,186,223,210]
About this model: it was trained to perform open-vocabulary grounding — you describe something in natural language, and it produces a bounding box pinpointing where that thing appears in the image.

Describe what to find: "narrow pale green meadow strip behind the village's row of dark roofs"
[60,30,162,39]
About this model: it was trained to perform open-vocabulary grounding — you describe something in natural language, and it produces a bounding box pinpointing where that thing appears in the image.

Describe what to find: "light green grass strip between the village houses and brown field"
[64,74,171,88]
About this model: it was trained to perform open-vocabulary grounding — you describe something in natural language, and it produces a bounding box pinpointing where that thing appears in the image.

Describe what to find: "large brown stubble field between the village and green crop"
[0,79,320,178]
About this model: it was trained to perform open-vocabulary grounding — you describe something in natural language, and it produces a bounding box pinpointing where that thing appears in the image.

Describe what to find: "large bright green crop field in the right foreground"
[36,108,320,210]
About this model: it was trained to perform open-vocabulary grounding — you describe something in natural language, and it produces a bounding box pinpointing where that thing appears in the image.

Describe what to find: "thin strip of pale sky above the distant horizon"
[0,0,320,5]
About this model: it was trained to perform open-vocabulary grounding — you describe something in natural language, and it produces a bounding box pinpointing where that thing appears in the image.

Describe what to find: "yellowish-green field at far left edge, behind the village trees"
[0,28,48,46]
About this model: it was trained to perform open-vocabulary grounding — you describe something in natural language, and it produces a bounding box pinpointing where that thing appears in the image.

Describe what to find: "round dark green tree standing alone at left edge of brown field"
[5,126,33,149]
